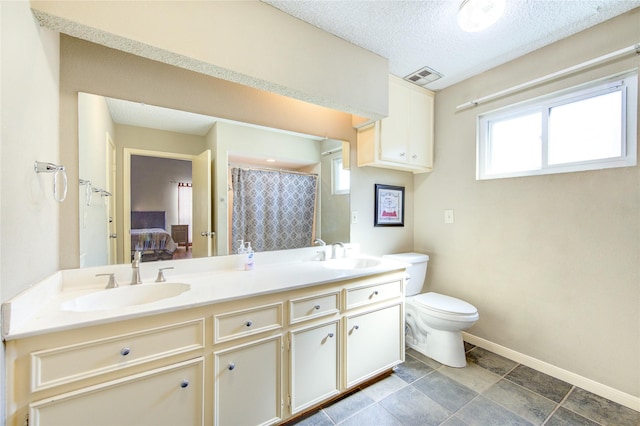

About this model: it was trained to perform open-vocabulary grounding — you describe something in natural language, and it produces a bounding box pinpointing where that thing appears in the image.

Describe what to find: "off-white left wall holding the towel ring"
[0,1,60,422]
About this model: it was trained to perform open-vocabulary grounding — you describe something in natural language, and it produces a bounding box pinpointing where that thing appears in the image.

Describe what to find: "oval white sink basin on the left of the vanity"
[60,283,191,312]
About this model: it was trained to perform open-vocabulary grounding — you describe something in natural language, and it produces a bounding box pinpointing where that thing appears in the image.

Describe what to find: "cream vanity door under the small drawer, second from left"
[214,335,282,426]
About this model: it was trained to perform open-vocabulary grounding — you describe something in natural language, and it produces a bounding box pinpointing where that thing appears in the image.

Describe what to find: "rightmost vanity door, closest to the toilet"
[345,304,404,386]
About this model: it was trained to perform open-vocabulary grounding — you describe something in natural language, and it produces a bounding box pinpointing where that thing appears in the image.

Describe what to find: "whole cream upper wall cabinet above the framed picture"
[358,75,434,173]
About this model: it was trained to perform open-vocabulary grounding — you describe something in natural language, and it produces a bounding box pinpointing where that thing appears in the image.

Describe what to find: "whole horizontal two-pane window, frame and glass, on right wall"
[477,73,638,179]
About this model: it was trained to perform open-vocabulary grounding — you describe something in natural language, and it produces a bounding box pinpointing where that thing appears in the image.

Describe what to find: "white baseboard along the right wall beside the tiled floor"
[462,331,640,411]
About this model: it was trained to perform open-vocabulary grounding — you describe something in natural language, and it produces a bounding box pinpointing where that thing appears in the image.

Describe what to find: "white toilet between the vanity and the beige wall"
[384,253,480,367]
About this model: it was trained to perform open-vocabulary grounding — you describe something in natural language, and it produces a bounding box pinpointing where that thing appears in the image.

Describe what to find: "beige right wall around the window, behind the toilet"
[414,9,640,408]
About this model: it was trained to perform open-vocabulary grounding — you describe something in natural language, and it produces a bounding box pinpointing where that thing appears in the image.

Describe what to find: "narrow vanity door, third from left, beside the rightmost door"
[290,321,340,414]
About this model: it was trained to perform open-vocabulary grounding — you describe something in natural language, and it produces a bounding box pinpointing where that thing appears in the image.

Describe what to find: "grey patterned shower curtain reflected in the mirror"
[231,168,318,253]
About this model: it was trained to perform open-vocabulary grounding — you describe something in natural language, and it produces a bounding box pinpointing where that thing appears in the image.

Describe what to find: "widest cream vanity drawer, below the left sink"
[31,319,204,392]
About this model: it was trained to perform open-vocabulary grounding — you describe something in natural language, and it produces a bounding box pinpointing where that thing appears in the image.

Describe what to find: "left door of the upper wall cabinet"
[380,79,409,163]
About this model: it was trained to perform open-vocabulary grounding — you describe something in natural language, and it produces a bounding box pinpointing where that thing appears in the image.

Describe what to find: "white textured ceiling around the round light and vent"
[262,0,640,90]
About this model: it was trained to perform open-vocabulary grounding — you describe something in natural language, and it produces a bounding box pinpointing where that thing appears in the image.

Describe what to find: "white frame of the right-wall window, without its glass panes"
[476,71,638,180]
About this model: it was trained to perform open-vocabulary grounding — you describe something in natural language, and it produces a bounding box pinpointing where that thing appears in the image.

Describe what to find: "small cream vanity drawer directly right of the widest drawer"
[214,303,283,343]
